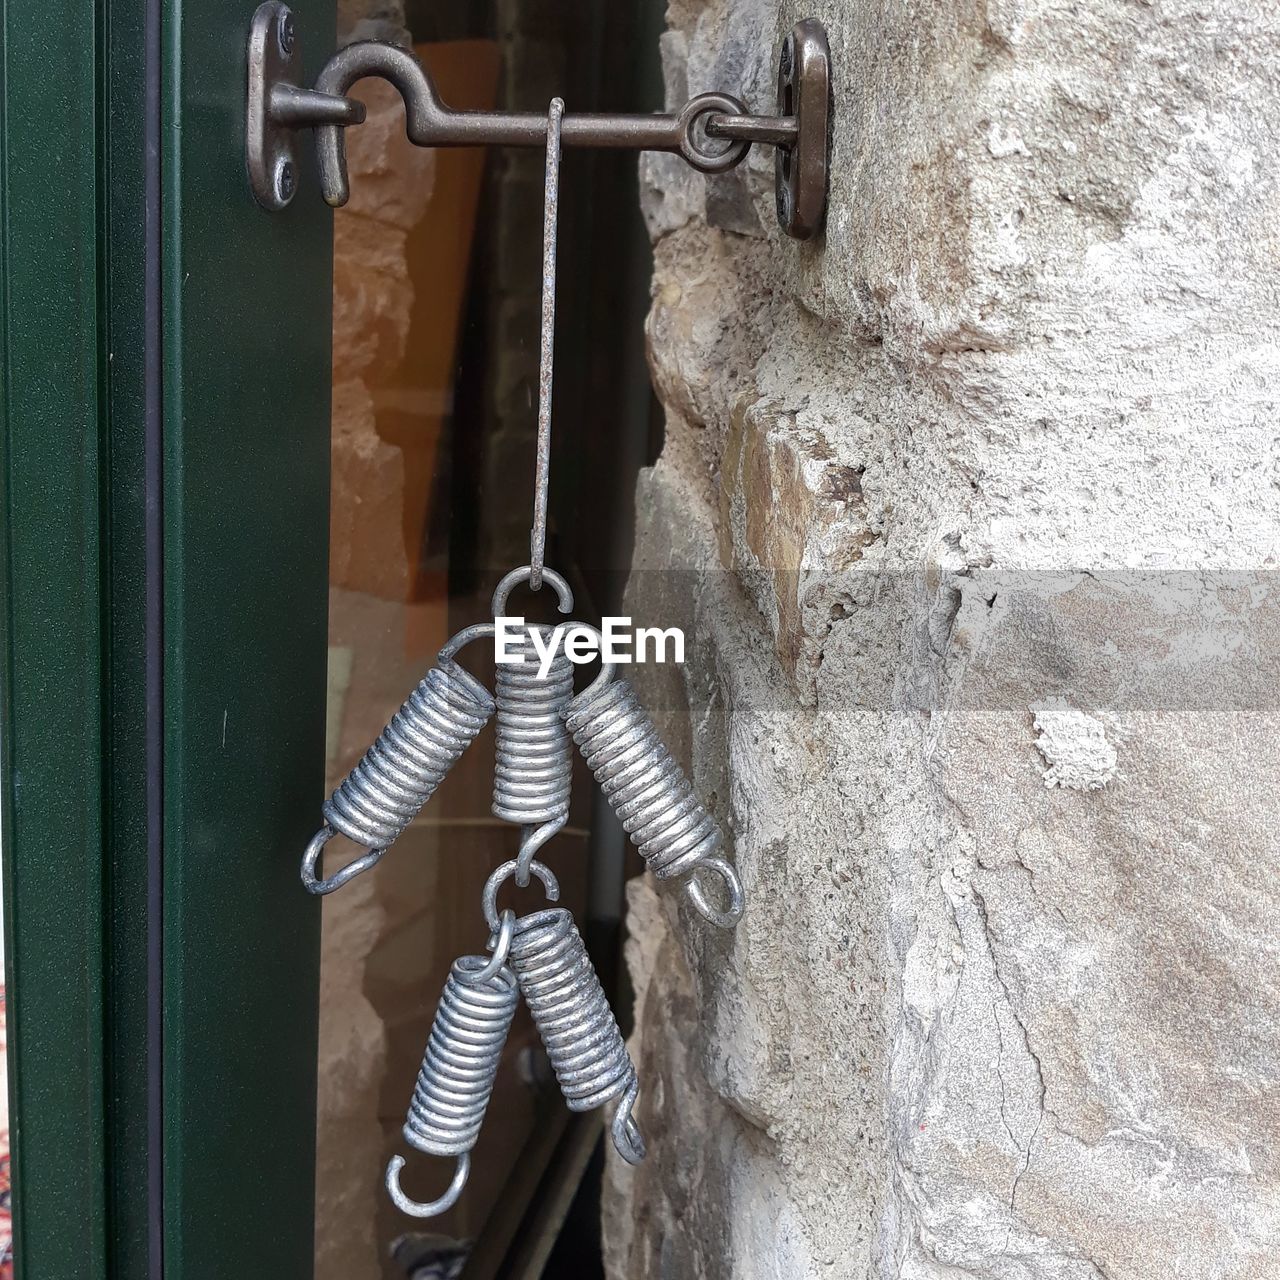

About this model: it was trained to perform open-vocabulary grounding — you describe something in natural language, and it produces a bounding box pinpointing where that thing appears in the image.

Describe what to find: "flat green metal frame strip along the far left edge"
[0,4,109,1277]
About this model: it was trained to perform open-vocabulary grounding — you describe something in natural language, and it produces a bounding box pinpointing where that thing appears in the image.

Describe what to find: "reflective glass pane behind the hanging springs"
[316,4,658,1280]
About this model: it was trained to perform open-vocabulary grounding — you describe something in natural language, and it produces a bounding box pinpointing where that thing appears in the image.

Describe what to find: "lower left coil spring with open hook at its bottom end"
[387,956,518,1217]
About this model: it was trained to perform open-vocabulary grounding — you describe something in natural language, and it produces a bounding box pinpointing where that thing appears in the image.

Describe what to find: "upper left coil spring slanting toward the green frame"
[302,650,494,893]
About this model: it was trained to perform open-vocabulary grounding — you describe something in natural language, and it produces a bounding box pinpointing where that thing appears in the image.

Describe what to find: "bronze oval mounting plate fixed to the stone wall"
[774,18,831,239]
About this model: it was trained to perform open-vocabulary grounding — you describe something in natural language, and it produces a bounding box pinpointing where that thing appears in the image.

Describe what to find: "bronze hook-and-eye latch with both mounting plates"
[244,0,831,239]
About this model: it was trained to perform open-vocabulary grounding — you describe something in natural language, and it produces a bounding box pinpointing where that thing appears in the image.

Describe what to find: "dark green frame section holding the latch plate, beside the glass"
[161,0,334,1280]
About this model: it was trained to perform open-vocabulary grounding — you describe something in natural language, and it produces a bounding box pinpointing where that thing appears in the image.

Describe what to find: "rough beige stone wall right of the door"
[605,0,1280,1280]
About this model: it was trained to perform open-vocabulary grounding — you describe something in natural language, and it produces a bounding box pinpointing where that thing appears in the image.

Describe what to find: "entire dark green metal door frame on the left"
[0,0,333,1280]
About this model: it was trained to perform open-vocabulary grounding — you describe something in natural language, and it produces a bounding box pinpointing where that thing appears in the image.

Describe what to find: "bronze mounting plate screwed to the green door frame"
[244,0,302,210]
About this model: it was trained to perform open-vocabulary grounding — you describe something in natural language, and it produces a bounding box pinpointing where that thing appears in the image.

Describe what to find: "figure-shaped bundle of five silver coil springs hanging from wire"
[302,566,744,1217]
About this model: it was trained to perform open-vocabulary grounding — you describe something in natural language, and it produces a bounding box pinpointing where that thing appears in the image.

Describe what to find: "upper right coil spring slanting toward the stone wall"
[564,680,742,928]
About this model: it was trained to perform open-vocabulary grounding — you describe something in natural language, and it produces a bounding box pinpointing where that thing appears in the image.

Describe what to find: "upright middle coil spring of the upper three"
[493,626,573,838]
